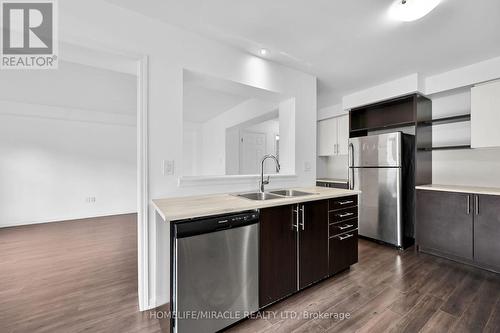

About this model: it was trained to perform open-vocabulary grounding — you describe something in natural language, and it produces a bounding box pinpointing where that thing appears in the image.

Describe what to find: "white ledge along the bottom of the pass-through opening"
[177,174,298,187]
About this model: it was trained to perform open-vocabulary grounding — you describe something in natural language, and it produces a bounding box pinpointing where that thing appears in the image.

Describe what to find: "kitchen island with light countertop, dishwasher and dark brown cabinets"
[153,187,359,332]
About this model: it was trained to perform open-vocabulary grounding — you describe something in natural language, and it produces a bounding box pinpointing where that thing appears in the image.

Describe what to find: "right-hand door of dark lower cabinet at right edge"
[474,195,500,271]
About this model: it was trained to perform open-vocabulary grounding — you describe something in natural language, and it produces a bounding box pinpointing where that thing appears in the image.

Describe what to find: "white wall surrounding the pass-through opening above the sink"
[59,0,316,306]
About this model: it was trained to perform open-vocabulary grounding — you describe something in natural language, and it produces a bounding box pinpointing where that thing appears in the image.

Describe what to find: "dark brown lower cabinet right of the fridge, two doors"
[417,190,500,272]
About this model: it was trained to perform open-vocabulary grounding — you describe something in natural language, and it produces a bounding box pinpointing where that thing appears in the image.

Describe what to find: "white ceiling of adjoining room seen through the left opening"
[0,60,137,116]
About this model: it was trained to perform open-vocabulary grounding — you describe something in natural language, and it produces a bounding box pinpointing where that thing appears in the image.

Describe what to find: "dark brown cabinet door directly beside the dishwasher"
[259,205,297,308]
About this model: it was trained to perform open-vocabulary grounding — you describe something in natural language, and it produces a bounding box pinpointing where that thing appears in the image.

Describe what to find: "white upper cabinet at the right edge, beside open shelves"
[471,81,500,148]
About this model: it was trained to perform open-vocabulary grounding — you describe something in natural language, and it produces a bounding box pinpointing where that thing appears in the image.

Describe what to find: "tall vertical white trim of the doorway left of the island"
[137,56,150,311]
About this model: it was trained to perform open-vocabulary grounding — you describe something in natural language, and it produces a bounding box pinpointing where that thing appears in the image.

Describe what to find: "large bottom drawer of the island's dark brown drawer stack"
[329,230,358,275]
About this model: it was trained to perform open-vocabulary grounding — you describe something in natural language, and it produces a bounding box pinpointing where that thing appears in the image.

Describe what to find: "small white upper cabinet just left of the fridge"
[318,115,349,156]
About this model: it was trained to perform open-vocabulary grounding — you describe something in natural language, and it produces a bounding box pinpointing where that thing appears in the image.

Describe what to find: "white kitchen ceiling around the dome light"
[106,0,500,106]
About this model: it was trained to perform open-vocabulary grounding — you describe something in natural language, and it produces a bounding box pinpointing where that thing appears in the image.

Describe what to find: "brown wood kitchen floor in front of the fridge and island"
[228,240,500,333]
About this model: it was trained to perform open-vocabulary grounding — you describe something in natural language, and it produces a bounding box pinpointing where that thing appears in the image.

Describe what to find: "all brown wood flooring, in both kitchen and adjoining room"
[0,215,500,333]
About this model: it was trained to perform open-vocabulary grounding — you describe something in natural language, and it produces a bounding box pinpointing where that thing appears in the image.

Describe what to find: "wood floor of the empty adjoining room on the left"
[0,214,161,333]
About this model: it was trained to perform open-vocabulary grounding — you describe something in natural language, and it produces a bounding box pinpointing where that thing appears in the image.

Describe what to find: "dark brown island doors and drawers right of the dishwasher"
[259,196,358,308]
